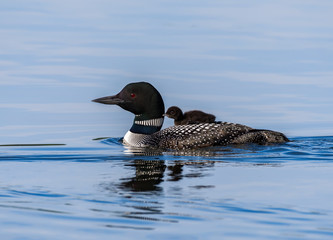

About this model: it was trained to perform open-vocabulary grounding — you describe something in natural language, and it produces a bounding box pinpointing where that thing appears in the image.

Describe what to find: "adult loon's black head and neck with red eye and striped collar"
[92,82,165,134]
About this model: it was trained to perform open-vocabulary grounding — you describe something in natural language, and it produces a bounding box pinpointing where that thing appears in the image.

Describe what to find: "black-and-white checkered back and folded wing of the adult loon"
[147,122,288,149]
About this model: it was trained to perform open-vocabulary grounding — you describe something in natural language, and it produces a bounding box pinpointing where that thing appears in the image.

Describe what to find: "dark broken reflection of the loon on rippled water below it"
[100,159,219,230]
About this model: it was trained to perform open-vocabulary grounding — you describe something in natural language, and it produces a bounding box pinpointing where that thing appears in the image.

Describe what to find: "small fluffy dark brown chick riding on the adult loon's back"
[164,106,215,126]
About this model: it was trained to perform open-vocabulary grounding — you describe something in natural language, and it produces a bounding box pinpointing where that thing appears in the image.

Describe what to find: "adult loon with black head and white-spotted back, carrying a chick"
[92,82,289,150]
